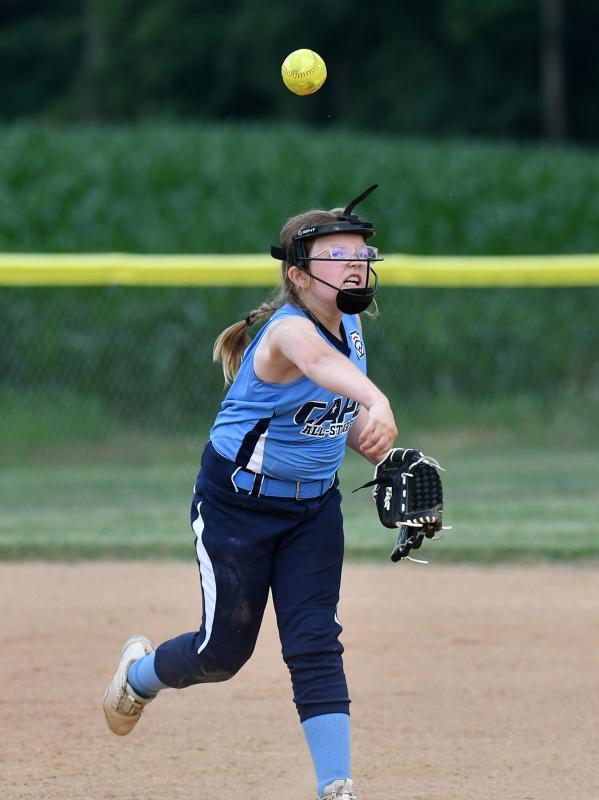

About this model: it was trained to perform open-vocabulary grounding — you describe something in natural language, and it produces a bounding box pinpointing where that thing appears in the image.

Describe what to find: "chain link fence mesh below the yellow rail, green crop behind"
[0,287,599,458]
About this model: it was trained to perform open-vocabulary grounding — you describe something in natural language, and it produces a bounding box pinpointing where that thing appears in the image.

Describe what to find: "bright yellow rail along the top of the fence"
[0,253,599,287]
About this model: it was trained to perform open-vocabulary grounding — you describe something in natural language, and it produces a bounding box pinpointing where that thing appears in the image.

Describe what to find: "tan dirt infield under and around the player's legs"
[0,563,599,800]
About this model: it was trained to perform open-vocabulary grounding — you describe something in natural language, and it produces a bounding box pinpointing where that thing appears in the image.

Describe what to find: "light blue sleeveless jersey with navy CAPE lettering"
[210,304,366,481]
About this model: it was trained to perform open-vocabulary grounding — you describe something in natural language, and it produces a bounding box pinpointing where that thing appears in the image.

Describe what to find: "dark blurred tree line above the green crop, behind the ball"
[0,0,599,144]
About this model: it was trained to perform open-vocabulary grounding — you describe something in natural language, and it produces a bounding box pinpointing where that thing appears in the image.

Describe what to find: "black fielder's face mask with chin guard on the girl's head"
[270,183,383,314]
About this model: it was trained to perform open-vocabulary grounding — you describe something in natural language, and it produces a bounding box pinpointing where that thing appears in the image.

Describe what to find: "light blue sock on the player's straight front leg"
[302,714,351,797]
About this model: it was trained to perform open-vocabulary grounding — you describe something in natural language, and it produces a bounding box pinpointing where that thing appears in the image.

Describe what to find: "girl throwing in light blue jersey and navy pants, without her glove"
[104,186,397,800]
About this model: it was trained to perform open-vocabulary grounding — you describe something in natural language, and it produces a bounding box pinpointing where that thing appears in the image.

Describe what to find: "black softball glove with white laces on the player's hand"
[354,447,446,561]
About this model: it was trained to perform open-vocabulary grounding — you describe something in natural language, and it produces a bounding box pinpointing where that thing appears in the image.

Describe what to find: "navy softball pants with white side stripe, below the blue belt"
[154,444,350,721]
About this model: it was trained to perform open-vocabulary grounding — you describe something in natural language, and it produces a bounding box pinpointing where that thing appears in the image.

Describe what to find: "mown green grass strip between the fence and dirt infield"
[0,428,599,563]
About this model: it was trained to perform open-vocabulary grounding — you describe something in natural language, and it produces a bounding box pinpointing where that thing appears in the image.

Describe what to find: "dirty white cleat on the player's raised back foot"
[104,636,154,736]
